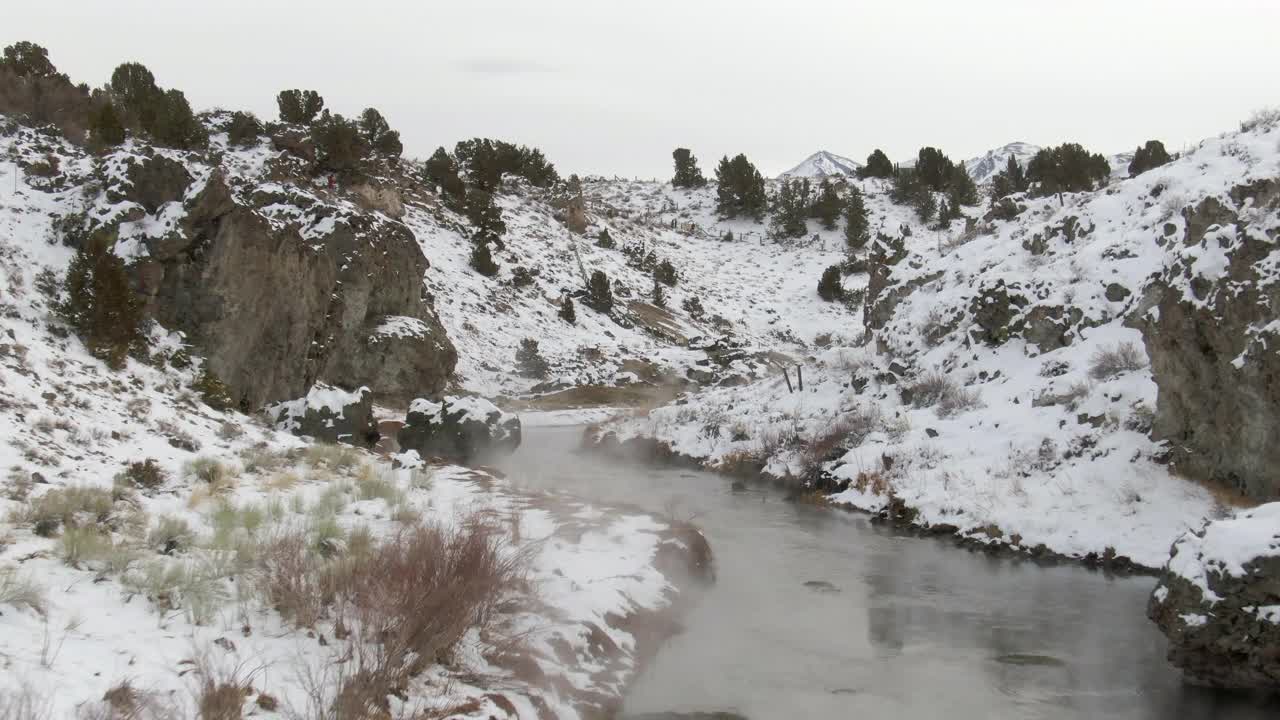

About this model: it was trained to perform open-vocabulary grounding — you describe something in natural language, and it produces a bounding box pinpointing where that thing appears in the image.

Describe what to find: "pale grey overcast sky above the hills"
[10,0,1280,177]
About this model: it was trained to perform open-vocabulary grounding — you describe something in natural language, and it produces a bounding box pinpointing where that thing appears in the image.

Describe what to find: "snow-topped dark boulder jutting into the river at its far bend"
[397,396,520,462]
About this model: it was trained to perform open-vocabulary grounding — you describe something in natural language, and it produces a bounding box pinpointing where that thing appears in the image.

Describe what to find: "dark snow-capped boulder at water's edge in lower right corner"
[1147,502,1280,691]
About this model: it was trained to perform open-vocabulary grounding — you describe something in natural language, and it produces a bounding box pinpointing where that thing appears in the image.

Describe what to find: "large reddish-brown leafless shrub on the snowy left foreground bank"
[259,515,525,717]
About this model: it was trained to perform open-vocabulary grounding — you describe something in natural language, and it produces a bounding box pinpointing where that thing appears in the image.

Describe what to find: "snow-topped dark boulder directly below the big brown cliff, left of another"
[268,383,379,447]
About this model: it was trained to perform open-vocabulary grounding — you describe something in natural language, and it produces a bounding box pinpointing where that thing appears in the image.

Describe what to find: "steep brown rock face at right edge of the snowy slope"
[1132,179,1280,500]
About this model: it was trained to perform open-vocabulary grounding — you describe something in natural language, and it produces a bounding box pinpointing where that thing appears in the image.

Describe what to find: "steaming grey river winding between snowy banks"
[503,428,1280,720]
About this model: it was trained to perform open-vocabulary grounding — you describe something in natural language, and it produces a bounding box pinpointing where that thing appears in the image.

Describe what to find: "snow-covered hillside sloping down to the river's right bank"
[588,114,1280,566]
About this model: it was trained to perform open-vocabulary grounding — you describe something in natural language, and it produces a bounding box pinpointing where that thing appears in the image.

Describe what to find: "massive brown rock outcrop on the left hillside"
[134,169,457,407]
